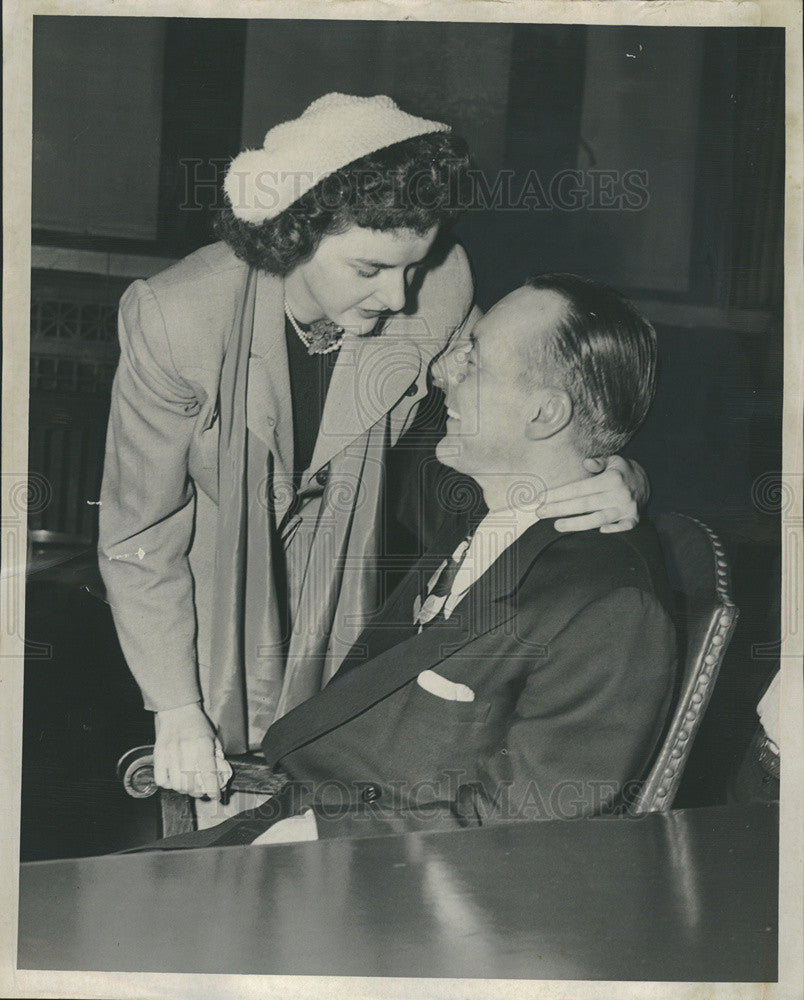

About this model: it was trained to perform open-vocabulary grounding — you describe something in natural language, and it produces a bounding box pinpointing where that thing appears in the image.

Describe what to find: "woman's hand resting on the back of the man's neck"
[539,455,650,533]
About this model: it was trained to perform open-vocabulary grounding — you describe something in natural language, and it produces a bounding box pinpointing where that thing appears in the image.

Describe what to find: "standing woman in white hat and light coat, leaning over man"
[100,94,639,808]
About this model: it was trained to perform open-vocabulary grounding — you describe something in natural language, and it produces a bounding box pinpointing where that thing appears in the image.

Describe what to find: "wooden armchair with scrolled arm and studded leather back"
[117,514,738,837]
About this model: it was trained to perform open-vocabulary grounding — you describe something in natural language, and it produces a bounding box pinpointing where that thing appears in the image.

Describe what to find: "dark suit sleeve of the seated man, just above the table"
[316,588,675,839]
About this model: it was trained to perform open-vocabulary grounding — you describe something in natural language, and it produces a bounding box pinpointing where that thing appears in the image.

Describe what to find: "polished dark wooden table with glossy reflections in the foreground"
[18,805,778,982]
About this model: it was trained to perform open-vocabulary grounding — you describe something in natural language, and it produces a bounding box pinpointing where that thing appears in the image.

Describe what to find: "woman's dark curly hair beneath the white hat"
[215,132,470,275]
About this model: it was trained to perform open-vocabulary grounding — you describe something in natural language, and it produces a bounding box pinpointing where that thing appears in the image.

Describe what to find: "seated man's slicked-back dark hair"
[525,274,656,458]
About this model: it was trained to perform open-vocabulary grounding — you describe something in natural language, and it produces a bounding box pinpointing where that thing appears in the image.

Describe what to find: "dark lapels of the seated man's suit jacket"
[262,520,560,766]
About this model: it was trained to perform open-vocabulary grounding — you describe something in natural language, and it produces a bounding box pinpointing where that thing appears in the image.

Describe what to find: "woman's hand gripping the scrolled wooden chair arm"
[154,704,232,799]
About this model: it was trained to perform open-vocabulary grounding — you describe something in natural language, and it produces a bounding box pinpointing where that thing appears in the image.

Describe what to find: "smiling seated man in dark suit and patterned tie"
[141,275,676,847]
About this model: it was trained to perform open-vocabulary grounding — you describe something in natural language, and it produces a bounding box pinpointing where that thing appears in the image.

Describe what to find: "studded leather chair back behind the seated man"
[630,514,739,813]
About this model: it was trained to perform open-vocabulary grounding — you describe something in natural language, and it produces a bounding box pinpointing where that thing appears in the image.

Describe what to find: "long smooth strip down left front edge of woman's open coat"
[207,268,293,753]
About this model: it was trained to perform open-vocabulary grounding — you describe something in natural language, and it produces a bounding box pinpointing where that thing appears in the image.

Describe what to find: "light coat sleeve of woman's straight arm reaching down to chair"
[99,281,207,711]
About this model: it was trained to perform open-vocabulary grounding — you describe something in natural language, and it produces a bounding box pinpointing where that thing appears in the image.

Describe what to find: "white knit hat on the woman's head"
[223,93,450,224]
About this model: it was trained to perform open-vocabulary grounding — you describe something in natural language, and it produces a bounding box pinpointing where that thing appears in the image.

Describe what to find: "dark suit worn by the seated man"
[146,521,676,847]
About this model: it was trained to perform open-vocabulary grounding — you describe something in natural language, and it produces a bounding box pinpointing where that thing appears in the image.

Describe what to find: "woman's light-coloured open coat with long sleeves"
[99,236,473,753]
